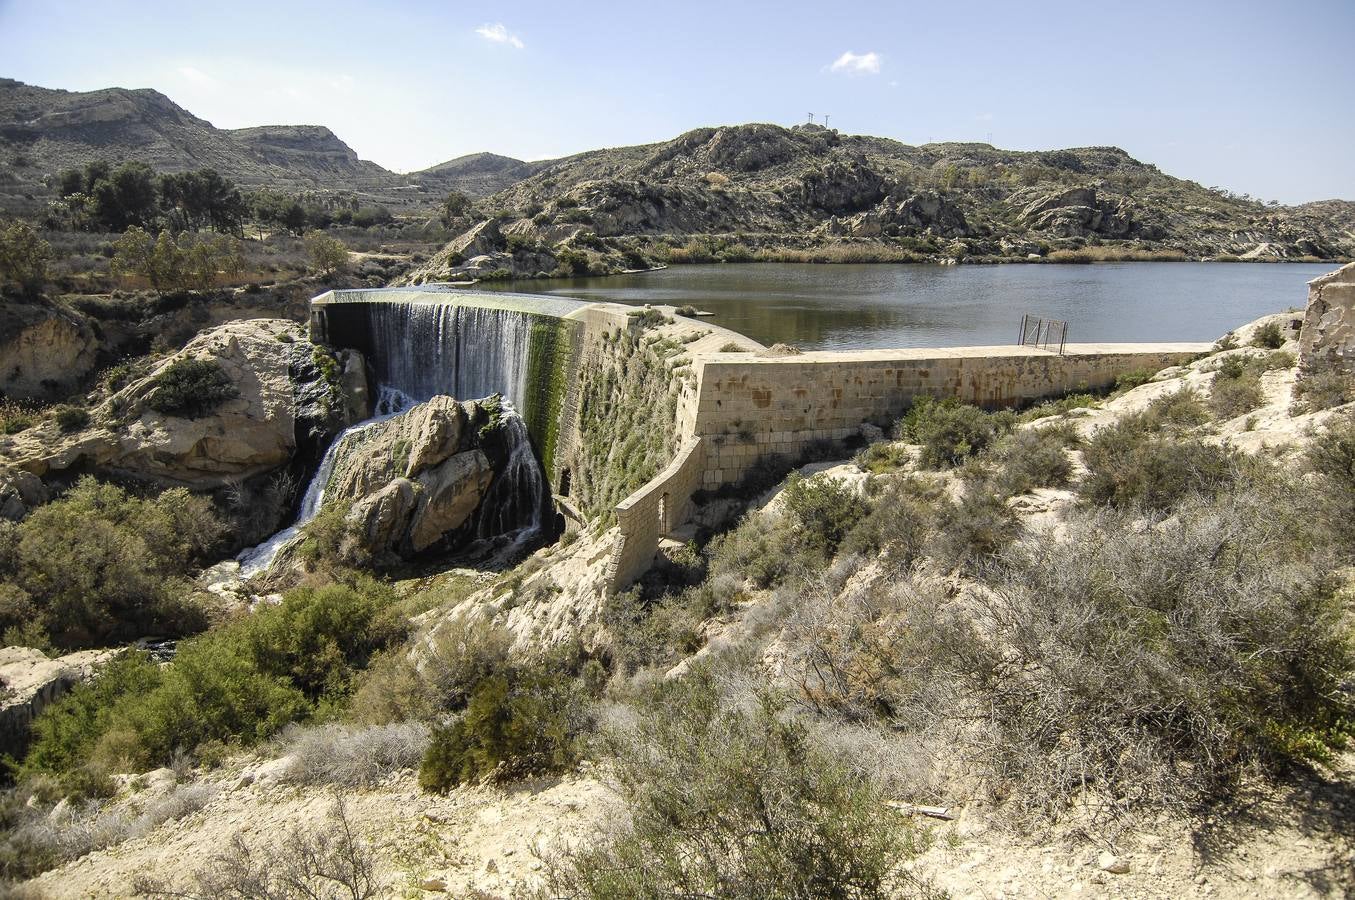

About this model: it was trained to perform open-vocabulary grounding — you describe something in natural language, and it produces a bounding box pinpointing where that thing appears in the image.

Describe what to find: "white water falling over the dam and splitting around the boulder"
[237,300,549,577]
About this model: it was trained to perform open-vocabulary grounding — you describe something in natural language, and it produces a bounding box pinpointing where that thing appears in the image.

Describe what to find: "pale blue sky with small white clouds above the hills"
[0,0,1355,203]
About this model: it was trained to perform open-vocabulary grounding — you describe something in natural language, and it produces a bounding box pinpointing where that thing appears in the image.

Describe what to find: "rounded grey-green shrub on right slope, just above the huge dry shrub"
[1079,416,1240,510]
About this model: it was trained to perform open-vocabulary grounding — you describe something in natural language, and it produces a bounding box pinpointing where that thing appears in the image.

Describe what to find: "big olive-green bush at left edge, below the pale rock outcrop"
[0,476,225,647]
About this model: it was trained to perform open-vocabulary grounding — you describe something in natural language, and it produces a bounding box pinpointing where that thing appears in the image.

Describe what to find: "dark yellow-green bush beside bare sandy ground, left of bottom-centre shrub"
[419,667,589,794]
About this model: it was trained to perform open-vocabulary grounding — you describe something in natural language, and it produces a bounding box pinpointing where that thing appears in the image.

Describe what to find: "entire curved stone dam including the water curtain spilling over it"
[310,285,1211,590]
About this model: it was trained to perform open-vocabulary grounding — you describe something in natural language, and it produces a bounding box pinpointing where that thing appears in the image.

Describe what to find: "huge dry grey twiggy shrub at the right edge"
[953,489,1355,815]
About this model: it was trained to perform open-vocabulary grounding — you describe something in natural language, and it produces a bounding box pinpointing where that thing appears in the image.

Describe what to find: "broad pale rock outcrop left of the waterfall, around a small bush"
[0,319,367,491]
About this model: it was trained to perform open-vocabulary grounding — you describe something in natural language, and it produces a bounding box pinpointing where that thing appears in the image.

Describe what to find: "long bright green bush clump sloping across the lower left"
[23,580,404,775]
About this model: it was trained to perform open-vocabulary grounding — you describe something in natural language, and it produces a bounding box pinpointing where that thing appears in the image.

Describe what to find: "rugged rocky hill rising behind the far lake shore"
[416,125,1355,279]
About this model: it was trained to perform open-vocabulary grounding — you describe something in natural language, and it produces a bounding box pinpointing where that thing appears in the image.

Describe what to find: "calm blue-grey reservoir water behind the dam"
[481,263,1337,350]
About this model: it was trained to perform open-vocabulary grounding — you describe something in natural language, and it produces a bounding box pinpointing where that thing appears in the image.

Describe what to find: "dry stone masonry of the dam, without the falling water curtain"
[312,286,1210,590]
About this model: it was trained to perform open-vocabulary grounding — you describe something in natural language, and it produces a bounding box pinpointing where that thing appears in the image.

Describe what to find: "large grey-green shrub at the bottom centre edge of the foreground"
[546,674,927,899]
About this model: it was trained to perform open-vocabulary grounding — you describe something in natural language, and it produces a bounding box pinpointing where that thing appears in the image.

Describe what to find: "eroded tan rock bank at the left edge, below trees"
[0,301,99,400]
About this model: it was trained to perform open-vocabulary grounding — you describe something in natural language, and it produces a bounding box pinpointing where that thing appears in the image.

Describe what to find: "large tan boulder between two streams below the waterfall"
[325,397,495,558]
